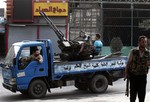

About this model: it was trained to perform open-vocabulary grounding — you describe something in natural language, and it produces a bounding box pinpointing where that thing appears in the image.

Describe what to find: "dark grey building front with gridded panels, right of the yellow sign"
[69,0,150,46]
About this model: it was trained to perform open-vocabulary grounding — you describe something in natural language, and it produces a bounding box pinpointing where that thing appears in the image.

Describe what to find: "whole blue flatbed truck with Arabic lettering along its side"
[1,39,127,98]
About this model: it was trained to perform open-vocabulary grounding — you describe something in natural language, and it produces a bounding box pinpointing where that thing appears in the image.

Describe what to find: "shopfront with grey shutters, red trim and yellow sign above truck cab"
[6,0,68,53]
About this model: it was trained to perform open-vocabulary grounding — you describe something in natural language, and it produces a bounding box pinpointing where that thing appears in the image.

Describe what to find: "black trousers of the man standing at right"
[130,75,147,102]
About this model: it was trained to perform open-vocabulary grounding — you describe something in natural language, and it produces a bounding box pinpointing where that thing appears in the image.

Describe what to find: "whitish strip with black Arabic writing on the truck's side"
[54,59,126,74]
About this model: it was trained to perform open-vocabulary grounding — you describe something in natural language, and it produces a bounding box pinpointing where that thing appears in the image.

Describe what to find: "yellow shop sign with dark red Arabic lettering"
[34,2,68,16]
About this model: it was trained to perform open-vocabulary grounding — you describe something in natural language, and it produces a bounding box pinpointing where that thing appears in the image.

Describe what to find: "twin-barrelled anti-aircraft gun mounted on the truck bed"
[40,12,93,61]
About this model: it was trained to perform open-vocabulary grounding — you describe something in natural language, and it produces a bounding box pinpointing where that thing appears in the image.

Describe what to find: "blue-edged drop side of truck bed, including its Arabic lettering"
[54,56,127,76]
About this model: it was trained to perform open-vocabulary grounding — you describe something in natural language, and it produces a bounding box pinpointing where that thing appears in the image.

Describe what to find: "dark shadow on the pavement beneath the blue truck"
[0,89,120,102]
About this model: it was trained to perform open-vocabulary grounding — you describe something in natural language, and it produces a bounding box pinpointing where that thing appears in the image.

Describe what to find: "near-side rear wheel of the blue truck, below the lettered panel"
[89,75,108,93]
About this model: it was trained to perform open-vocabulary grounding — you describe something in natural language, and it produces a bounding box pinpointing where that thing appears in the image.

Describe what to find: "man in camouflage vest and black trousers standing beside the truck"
[125,36,150,102]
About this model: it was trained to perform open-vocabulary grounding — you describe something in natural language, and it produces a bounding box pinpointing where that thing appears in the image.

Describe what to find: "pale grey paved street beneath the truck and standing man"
[0,66,150,102]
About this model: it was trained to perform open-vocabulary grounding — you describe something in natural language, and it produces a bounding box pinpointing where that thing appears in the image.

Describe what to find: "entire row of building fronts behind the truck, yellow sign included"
[4,0,150,56]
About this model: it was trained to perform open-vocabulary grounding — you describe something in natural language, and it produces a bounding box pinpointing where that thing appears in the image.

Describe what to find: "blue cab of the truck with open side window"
[2,40,53,95]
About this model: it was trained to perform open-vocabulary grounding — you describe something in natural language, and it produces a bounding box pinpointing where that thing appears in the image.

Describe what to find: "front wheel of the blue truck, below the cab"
[28,80,47,98]
